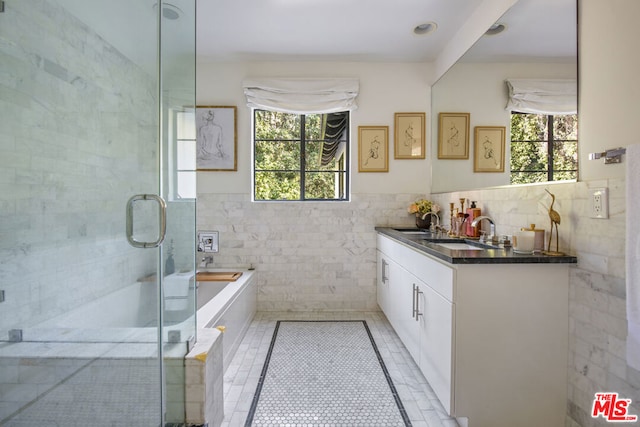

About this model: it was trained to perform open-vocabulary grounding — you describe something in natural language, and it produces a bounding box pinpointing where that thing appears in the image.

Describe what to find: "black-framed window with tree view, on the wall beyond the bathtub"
[253,109,350,201]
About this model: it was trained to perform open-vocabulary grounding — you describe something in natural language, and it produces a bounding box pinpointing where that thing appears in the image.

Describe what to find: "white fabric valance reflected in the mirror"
[506,79,578,114]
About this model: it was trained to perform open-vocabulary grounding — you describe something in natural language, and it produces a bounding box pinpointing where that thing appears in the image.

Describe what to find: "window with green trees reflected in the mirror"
[511,112,578,184]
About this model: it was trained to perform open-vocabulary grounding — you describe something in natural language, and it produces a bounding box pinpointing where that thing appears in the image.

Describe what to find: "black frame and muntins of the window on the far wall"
[251,108,351,203]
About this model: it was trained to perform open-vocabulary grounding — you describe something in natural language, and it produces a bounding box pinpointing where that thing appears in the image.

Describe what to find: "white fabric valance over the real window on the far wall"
[243,77,359,114]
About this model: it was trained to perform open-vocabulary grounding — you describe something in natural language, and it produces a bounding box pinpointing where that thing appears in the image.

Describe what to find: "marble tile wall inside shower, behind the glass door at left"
[0,0,157,335]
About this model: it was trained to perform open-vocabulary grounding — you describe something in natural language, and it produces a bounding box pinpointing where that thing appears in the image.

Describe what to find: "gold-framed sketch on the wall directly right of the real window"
[358,126,389,172]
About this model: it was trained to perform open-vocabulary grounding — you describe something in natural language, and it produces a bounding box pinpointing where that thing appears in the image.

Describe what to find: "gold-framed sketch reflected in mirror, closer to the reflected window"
[473,126,506,172]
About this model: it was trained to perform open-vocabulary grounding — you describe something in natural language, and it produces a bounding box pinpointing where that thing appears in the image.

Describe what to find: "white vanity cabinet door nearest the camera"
[418,282,454,414]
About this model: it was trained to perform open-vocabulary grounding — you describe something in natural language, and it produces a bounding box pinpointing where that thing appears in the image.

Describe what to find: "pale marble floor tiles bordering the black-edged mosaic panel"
[222,312,458,427]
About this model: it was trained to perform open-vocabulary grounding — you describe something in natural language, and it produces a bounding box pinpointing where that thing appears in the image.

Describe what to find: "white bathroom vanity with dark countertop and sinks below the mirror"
[376,227,577,427]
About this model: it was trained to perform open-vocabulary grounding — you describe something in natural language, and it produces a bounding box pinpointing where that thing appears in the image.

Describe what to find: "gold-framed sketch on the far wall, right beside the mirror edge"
[393,113,426,159]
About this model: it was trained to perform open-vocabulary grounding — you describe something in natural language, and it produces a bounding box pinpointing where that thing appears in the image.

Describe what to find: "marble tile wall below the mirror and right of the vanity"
[433,179,640,427]
